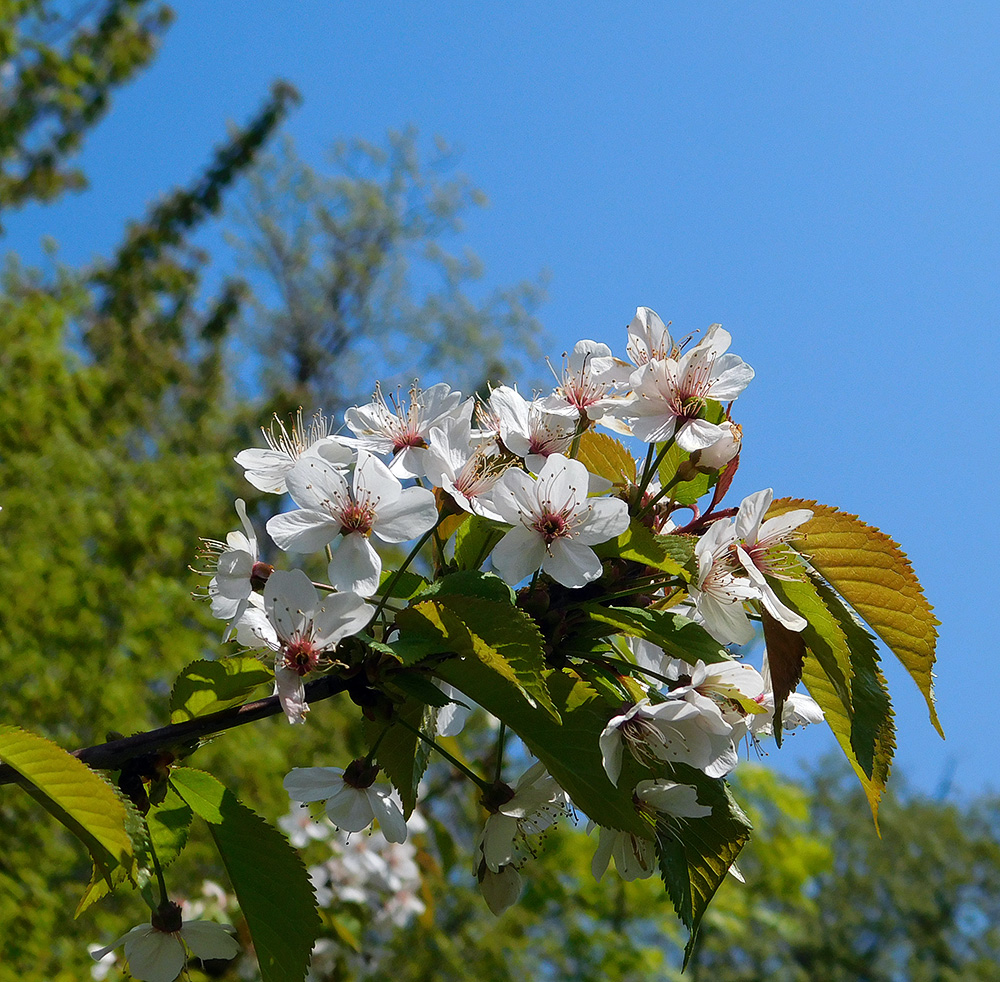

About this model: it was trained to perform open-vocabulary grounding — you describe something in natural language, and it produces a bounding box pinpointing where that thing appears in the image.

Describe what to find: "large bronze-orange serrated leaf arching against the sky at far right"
[767,498,944,736]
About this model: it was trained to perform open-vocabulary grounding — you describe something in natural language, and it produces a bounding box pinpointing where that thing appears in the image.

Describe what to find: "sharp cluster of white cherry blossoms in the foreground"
[188,307,822,932]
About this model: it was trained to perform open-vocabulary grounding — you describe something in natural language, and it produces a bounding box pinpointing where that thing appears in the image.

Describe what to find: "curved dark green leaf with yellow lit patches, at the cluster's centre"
[396,596,559,720]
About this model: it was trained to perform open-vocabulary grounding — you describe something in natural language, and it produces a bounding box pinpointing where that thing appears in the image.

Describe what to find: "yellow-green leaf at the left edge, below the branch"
[0,723,134,885]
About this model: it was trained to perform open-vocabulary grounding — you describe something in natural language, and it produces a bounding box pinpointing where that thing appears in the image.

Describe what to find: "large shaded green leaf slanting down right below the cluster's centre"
[438,658,650,838]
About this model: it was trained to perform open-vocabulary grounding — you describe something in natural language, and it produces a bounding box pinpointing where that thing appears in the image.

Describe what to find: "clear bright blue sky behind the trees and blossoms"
[6,0,1000,792]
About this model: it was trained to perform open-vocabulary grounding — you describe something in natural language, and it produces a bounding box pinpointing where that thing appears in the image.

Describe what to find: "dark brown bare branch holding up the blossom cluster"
[0,675,352,785]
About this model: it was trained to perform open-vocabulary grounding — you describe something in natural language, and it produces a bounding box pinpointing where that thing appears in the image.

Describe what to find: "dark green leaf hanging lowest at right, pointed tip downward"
[656,764,753,966]
